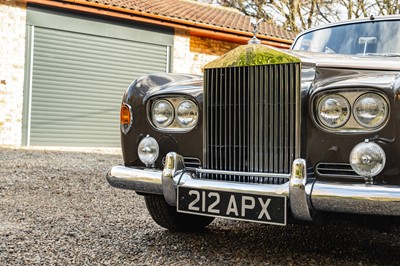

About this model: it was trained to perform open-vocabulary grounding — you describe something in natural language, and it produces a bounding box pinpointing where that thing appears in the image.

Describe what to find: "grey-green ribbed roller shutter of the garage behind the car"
[26,7,169,147]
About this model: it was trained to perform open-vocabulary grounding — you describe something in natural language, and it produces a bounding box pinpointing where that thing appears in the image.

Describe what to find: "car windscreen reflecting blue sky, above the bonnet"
[293,20,400,55]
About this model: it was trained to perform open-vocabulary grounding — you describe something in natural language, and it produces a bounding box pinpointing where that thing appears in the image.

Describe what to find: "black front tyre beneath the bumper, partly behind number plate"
[144,195,214,232]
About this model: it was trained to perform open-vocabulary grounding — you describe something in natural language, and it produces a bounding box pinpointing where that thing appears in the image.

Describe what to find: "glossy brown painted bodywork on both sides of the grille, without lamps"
[121,52,400,185]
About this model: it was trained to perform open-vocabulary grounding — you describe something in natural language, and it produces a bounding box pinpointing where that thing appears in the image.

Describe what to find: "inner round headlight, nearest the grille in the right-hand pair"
[317,94,350,128]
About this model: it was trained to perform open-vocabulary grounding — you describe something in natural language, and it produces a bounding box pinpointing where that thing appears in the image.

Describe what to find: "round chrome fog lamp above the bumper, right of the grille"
[350,141,386,177]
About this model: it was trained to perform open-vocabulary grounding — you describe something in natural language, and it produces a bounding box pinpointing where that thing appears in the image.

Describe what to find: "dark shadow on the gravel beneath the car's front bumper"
[146,221,400,265]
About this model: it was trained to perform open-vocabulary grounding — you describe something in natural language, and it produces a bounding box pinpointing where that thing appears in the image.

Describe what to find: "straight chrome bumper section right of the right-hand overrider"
[311,181,400,216]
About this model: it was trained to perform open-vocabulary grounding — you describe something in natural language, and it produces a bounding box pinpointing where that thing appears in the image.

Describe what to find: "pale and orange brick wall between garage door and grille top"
[172,30,239,74]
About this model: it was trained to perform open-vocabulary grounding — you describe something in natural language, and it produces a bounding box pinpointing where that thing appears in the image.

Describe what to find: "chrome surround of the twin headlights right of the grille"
[311,88,390,134]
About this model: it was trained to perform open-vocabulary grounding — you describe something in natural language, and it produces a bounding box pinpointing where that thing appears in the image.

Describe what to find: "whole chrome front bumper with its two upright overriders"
[106,152,400,221]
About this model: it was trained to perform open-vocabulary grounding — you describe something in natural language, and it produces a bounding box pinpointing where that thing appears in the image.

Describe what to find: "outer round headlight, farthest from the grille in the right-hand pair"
[353,93,388,128]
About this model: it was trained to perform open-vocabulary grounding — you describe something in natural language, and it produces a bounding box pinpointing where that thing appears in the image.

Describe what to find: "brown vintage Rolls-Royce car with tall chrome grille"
[106,16,400,231]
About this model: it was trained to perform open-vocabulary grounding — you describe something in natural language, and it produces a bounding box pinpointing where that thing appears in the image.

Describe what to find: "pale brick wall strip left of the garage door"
[0,0,26,146]
